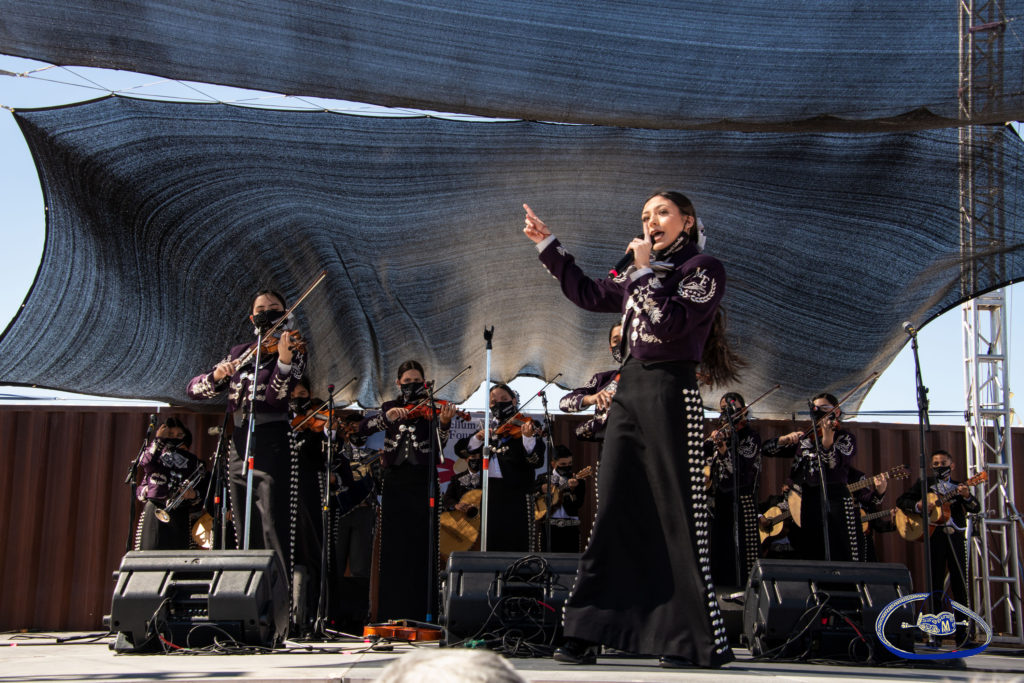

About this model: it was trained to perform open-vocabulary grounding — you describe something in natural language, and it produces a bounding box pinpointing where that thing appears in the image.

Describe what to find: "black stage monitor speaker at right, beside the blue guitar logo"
[743,560,914,661]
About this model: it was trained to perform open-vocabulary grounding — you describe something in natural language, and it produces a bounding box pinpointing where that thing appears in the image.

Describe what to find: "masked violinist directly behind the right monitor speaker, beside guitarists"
[762,393,864,561]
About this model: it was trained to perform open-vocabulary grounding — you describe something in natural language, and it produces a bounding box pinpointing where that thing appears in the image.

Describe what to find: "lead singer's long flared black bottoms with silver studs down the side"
[564,358,733,667]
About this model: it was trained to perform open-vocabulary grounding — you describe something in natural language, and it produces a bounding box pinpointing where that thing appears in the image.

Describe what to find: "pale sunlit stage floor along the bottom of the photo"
[0,633,1024,683]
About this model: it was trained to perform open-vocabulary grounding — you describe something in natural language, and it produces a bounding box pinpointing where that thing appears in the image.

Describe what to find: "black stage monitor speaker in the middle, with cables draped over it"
[440,551,580,645]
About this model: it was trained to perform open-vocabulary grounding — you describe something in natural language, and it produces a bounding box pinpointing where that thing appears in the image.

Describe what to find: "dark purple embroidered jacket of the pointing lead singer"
[537,236,725,362]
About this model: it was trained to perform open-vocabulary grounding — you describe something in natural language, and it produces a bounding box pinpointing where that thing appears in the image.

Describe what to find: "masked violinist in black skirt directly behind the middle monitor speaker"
[455,384,545,553]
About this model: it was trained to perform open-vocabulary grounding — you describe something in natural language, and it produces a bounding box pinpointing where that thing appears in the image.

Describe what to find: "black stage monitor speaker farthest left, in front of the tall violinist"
[103,550,288,651]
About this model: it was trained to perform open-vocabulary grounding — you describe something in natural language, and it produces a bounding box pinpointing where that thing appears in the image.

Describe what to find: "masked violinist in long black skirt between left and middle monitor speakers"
[356,360,455,622]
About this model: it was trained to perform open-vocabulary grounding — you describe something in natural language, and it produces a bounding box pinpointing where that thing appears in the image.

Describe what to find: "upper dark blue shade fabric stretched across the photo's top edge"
[0,0,1024,131]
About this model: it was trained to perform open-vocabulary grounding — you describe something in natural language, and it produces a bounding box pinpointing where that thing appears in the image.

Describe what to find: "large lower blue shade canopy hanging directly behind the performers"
[0,97,1024,416]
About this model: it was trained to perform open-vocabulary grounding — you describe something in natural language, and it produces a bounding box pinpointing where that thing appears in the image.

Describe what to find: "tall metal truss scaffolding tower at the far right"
[958,0,1024,644]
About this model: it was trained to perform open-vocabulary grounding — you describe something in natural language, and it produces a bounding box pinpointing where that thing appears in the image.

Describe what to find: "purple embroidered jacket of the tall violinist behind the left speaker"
[187,343,306,420]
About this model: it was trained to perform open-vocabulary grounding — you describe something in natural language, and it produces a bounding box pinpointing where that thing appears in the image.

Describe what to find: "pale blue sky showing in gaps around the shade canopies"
[0,55,1024,425]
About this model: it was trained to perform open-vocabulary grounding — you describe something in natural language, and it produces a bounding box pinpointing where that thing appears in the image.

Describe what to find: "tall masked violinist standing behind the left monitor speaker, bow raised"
[187,290,306,584]
